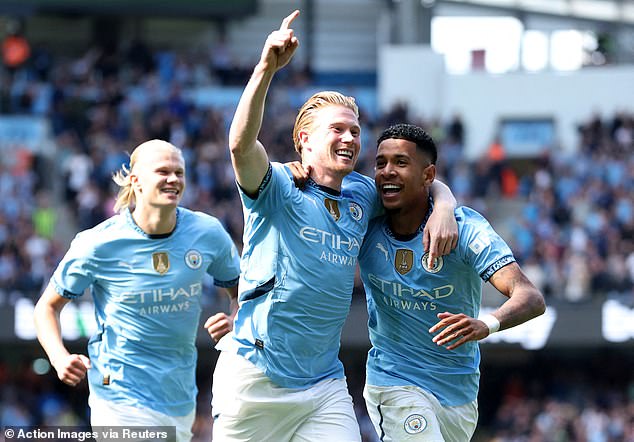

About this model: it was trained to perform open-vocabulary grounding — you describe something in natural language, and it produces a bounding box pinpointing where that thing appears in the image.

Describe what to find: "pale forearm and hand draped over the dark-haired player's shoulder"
[423,180,458,267]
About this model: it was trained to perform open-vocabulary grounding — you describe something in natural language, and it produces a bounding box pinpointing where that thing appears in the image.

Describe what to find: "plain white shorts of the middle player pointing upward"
[211,351,361,442]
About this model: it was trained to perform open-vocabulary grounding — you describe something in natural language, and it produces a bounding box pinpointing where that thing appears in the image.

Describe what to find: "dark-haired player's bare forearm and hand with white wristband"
[429,262,546,350]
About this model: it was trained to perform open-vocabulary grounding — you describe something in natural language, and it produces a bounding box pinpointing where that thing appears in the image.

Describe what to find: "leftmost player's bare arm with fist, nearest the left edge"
[34,284,90,386]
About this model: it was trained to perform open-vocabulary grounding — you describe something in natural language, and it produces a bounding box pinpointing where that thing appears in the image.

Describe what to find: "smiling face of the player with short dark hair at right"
[374,138,436,213]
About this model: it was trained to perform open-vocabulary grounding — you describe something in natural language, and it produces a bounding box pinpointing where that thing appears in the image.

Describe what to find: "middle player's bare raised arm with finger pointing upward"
[229,10,299,194]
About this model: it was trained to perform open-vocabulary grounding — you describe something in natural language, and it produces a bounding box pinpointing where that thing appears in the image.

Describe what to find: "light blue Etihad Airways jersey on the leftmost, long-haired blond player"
[52,208,240,416]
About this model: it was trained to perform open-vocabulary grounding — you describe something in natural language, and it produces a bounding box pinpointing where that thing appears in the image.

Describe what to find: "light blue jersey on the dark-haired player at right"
[359,207,515,406]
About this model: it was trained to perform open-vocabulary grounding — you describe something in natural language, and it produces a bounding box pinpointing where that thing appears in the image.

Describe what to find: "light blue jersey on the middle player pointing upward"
[216,163,380,388]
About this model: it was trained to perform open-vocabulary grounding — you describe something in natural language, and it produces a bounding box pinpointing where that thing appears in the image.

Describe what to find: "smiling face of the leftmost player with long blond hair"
[130,140,185,209]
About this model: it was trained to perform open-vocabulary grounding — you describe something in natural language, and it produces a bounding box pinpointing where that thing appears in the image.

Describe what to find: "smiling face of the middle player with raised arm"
[299,105,361,189]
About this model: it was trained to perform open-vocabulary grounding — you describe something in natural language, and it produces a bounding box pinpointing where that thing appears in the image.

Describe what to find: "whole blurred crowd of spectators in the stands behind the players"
[0,36,634,442]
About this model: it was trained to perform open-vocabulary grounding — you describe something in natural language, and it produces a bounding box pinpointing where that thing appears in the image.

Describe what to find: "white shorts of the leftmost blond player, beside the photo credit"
[88,394,196,442]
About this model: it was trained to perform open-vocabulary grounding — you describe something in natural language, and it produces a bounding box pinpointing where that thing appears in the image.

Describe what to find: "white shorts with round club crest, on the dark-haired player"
[363,384,478,442]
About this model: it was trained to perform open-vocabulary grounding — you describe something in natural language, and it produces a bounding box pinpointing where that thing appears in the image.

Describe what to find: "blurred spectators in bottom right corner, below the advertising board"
[484,352,634,442]
